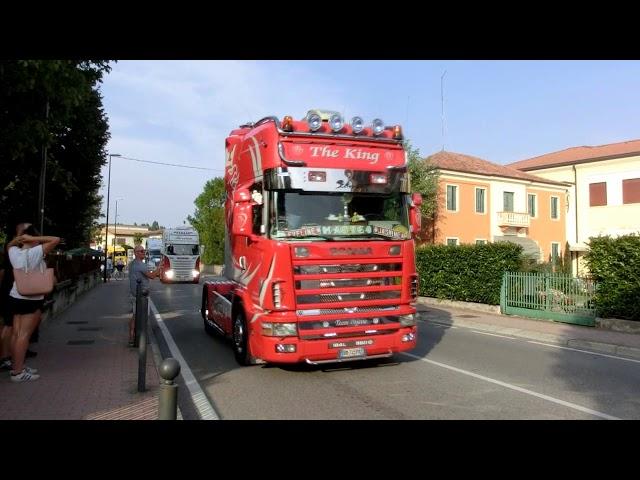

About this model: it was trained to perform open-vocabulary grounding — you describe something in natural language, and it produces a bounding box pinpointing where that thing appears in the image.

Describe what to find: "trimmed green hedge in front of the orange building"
[416,242,522,305]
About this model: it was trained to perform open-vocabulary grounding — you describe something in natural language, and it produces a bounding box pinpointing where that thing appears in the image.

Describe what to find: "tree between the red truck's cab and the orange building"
[404,140,438,240]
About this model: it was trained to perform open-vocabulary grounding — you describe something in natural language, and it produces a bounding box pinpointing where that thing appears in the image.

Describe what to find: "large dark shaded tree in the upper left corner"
[0,60,110,248]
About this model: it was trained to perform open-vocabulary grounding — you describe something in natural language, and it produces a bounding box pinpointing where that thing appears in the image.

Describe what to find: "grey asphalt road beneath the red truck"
[151,282,640,420]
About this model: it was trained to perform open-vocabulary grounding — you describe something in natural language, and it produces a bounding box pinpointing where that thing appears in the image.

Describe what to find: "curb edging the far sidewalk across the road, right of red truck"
[418,312,640,359]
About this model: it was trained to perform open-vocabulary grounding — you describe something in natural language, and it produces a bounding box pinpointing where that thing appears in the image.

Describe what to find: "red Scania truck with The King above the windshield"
[201,110,422,365]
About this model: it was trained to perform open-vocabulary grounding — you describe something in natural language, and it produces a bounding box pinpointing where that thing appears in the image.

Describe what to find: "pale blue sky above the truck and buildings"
[100,60,640,227]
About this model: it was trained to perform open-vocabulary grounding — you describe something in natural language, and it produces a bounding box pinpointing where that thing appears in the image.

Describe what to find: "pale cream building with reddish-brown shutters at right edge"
[508,140,640,274]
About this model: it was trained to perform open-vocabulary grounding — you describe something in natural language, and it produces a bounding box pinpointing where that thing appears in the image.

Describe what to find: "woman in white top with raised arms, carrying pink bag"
[8,225,60,382]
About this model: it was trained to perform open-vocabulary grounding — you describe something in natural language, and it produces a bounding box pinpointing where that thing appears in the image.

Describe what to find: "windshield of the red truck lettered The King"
[269,191,410,240]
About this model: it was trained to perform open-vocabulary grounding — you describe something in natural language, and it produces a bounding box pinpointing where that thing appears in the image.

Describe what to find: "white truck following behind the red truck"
[160,227,200,283]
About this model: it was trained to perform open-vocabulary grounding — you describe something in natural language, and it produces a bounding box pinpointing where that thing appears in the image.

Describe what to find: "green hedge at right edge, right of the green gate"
[585,234,640,320]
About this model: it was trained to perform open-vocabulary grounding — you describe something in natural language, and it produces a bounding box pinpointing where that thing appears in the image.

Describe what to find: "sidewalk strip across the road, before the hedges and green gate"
[416,297,640,359]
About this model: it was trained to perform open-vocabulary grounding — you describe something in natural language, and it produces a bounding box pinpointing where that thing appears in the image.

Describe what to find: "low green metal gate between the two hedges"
[500,272,596,327]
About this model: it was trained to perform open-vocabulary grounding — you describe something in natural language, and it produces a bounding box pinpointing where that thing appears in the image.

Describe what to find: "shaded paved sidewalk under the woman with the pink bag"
[0,280,159,420]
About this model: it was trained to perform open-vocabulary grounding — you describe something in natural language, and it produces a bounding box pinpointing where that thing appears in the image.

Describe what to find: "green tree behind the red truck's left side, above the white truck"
[188,178,226,265]
